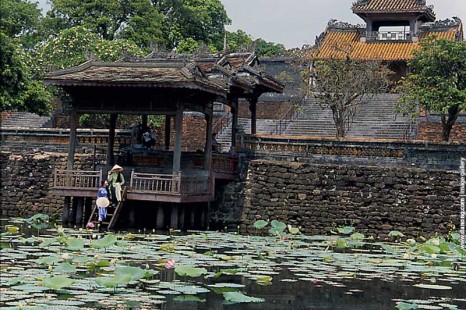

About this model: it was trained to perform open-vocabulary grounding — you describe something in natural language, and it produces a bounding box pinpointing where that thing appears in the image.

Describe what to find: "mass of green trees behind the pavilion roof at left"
[0,0,288,114]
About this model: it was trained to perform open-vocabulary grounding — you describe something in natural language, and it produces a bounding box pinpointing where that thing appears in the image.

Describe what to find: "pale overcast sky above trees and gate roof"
[36,0,466,48]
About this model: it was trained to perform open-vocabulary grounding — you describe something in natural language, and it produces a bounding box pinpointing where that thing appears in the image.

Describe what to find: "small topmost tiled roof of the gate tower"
[353,0,429,12]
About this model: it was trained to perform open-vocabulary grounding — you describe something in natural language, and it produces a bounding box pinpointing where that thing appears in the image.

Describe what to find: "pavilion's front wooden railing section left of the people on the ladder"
[53,170,102,189]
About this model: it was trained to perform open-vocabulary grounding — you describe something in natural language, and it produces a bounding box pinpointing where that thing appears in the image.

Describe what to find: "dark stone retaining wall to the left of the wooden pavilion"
[0,152,99,217]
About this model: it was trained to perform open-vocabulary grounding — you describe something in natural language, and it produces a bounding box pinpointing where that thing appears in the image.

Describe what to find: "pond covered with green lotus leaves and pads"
[0,215,466,309]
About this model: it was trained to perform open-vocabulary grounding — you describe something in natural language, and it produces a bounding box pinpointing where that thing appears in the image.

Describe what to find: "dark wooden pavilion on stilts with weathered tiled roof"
[45,53,283,228]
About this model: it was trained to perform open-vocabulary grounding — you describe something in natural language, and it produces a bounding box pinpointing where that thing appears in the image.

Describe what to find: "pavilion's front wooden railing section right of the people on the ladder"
[130,171,181,194]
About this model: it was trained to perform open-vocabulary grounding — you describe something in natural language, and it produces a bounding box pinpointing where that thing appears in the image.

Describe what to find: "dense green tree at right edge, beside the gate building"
[398,37,466,141]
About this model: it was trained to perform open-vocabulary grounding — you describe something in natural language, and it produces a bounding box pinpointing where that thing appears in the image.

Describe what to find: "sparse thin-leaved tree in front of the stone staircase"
[305,47,390,138]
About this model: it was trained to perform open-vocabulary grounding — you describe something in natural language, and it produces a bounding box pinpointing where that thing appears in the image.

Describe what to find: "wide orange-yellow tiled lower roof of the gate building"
[313,29,457,61]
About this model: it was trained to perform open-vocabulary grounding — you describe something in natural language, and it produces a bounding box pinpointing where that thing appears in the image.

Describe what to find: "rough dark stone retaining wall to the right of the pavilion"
[237,160,459,239]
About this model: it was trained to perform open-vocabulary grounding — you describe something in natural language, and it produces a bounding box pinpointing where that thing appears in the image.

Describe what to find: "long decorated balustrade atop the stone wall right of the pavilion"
[240,135,466,170]
